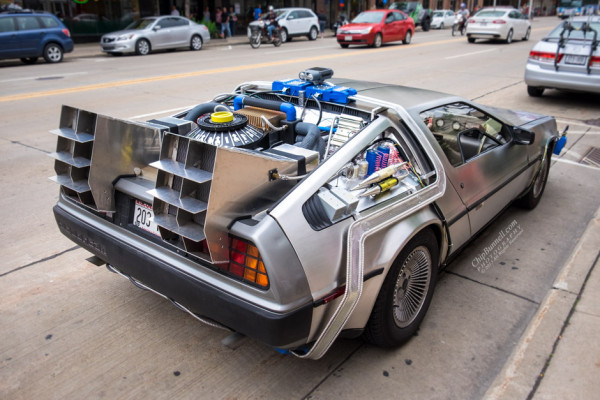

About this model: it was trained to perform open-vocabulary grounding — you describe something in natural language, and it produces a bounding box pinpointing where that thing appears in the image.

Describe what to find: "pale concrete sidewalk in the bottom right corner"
[485,208,600,400]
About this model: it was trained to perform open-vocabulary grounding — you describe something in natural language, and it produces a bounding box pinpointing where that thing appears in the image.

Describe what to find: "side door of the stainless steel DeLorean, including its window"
[421,103,532,235]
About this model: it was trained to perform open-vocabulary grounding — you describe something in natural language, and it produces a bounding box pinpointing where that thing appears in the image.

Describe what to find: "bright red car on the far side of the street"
[337,10,415,48]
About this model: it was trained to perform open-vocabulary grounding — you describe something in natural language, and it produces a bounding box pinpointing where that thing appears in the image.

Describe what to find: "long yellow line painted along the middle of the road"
[0,38,460,103]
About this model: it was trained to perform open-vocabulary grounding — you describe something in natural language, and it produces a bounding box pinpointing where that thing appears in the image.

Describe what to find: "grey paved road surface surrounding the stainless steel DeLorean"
[0,18,600,399]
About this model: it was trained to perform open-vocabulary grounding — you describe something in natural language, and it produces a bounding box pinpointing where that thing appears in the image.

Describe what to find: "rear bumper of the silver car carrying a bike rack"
[525,62,600,93]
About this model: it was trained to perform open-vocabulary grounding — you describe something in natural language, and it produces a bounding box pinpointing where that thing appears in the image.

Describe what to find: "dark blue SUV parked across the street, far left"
[0,12,73,64]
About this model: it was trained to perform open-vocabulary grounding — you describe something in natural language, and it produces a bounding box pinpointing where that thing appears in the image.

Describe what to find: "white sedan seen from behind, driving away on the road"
[467,7,531,43]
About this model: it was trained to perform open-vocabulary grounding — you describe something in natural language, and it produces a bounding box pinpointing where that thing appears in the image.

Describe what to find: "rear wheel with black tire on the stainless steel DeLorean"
[364,229,439,347]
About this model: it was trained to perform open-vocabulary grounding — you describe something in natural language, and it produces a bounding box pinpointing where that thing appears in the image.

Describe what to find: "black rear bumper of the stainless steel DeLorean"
[54,203,313,348]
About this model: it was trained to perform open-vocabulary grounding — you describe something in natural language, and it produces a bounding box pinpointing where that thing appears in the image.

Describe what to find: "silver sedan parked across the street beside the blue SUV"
[100,15,210,56]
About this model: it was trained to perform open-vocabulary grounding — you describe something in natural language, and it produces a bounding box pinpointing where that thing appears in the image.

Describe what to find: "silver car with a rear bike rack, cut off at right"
[525,16,600,97]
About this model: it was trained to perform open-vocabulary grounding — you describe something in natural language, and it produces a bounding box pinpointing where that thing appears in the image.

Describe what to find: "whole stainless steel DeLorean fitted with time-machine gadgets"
[52,68,557,359]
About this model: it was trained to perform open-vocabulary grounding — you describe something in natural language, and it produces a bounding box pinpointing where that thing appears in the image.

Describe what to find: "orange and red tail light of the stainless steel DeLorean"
[228,237,269,288]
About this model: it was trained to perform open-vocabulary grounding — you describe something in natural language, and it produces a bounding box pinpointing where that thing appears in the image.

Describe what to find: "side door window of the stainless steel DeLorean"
[420,103,510,167]
